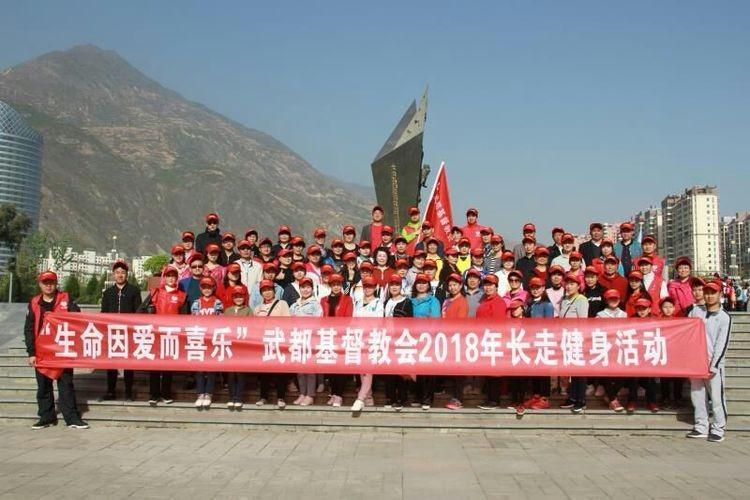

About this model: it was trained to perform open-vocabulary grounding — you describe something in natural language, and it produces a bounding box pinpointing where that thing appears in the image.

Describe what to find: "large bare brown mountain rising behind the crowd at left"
[0,45,373,255]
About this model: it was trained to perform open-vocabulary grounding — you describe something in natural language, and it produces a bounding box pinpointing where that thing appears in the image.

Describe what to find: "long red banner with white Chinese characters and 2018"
[36,313,708,377]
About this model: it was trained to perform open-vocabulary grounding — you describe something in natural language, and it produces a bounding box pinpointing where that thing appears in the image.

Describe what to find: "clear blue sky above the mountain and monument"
[0,0,750,237]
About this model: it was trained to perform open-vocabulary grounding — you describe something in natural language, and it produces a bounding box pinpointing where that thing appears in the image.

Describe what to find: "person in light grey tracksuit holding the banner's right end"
[687,281,732,443]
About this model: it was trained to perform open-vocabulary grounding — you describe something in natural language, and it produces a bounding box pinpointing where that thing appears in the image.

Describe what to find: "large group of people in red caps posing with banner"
[26,206,730,442]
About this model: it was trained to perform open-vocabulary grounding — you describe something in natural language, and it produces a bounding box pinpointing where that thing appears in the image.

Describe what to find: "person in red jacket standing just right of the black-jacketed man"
[138,266,189,406]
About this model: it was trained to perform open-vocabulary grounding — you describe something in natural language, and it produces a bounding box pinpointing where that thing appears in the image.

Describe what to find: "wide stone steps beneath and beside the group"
[0,313,750,433]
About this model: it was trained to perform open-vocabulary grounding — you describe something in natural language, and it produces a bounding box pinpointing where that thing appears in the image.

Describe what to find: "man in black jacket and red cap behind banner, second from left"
[99,260,141,401]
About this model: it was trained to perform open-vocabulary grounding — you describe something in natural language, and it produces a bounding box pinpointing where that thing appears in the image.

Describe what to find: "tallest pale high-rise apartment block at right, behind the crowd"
[660,186,722,276]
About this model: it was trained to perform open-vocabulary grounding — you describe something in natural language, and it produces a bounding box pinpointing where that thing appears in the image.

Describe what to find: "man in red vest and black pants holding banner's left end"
[24,271,89,429]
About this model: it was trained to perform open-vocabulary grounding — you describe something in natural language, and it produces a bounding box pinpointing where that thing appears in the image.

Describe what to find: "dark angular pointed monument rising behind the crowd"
[372,89,429,230]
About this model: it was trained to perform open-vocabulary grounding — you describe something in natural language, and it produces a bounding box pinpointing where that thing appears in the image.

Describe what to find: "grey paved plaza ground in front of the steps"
[0,424,750,499]
